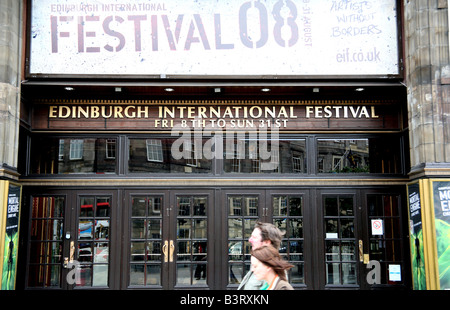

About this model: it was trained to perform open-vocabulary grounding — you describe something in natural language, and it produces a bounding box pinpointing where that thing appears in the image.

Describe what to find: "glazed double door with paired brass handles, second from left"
[123,190,214,289]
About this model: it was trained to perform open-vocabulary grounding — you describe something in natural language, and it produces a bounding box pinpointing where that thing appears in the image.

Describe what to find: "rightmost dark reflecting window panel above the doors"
[317,137,402,173]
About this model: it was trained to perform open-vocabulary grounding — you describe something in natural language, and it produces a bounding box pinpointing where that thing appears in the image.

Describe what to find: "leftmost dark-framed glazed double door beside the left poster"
[26,191,117,289]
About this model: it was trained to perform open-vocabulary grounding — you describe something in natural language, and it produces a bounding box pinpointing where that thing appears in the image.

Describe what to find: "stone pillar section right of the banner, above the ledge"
[404,0,450,178]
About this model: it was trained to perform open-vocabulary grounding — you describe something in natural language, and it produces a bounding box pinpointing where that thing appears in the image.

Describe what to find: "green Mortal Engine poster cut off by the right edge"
[433,181,450,290]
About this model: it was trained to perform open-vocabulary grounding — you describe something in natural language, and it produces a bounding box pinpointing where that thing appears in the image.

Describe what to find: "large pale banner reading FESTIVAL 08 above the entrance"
[28,0,399,78]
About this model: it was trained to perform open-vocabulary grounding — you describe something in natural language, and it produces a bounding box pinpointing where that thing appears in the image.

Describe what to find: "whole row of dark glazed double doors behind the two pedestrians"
[22,187,409,290]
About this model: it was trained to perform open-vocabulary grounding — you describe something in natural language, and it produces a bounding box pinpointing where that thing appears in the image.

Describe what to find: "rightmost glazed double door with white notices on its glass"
[318,189,408,289]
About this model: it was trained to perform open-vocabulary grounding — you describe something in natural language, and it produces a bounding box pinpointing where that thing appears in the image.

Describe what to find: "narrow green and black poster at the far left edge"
[1,183,21,290]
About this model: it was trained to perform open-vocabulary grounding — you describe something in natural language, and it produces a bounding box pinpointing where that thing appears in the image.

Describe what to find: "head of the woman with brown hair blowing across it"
[251,245,293,280]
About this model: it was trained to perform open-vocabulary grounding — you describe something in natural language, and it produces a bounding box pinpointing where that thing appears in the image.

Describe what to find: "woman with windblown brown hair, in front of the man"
[251,245,294,290]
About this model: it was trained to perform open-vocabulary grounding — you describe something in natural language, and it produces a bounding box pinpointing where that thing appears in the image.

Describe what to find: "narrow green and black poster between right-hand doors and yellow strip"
[408,183,427,290]
